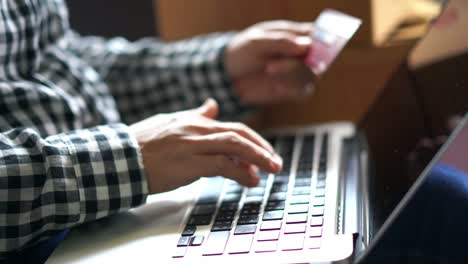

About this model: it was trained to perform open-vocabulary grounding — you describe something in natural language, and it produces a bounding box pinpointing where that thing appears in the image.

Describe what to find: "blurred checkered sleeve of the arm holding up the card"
[69,32,250,123]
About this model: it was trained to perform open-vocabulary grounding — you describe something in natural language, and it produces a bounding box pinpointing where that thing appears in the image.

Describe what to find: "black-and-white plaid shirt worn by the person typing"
[0,0,247,256]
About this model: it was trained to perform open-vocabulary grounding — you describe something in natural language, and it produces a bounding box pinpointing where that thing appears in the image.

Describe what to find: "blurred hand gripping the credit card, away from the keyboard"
[225,21,316,104]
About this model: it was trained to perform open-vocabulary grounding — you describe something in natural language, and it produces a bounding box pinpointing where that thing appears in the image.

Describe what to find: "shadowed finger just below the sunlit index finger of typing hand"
[193,155,259,187]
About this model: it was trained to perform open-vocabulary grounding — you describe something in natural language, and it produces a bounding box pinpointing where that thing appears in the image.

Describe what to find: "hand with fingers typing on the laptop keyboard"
[130,99,282,193]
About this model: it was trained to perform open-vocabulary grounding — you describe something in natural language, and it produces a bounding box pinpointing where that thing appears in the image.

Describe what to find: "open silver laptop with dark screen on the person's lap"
[48,0,468,263]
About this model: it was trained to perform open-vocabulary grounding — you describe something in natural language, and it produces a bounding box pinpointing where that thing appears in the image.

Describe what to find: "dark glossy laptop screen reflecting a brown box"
[359,0,468,238]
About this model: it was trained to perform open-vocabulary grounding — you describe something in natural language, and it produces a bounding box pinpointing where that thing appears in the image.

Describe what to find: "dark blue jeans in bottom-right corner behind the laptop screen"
[362,164,468,264]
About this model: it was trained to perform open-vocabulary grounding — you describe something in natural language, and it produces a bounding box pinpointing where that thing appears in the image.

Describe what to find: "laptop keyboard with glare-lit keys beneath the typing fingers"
[173,134,328,258]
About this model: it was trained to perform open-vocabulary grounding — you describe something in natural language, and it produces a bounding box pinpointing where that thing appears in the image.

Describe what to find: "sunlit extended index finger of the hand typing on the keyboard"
[187,131,282,173]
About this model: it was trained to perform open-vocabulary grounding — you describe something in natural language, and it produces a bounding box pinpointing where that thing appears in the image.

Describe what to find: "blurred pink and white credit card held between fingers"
[305,9,361,76]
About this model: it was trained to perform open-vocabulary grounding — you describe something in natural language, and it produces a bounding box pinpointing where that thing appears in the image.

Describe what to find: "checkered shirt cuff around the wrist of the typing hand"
[60,124,148,223]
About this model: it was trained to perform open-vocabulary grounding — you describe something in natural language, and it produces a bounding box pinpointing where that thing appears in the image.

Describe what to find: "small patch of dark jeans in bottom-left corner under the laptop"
[0,229,69,264]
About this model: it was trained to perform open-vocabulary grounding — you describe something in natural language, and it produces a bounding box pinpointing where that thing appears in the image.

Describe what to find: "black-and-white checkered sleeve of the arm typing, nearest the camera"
[0,124,148,257]
